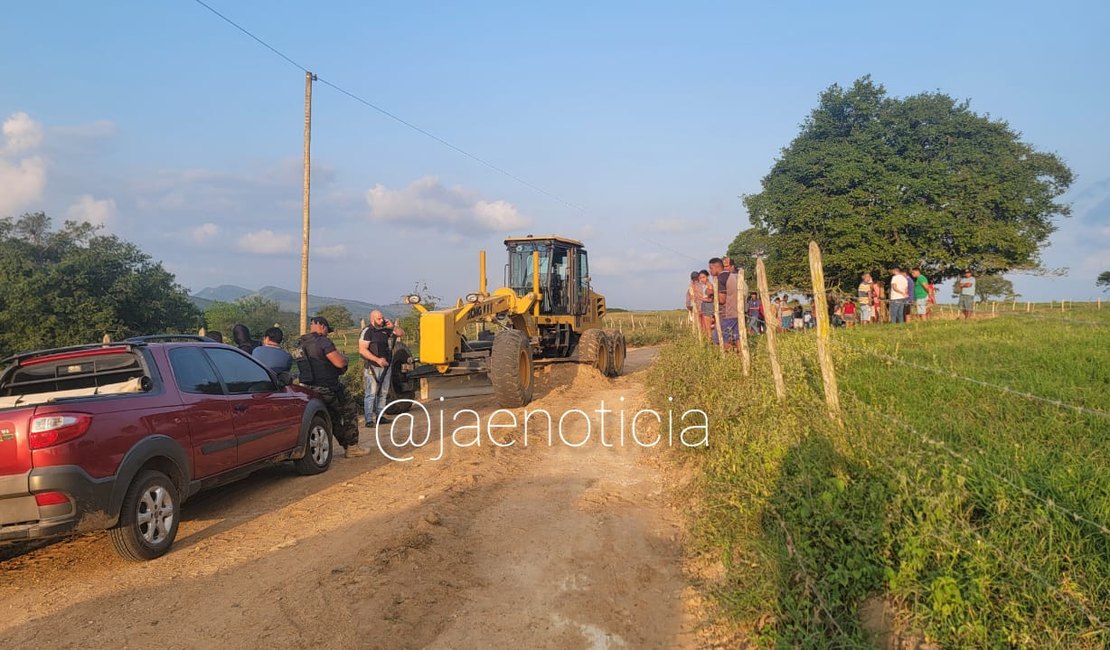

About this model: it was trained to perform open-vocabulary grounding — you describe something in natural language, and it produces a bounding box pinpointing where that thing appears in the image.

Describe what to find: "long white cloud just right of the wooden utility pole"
[366,176,531,234]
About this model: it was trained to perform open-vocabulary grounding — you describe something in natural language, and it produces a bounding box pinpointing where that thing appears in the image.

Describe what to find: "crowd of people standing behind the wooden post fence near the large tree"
[686,257,976,337]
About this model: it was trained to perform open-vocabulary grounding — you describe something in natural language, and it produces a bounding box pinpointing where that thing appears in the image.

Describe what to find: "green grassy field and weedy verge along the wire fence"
[649,305,1110,648]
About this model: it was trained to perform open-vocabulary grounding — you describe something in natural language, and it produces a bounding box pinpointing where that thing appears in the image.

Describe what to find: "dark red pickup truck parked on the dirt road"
[0,336,332,560]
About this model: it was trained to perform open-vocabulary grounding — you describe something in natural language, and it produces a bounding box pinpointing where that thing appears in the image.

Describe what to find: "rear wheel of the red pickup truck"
[108,469,181,561]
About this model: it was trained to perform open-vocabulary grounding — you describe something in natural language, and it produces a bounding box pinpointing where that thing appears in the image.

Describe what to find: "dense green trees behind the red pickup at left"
[0,212,201,355]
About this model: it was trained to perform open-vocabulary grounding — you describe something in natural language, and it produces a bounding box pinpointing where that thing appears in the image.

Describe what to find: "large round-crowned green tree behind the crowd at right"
[744,77,1072,287]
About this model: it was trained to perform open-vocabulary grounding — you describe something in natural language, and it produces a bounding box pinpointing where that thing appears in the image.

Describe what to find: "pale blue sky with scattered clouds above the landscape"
[0,0,1110,308]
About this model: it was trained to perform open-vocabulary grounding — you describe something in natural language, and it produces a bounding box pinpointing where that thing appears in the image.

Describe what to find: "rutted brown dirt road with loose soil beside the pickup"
[0,349,697,648]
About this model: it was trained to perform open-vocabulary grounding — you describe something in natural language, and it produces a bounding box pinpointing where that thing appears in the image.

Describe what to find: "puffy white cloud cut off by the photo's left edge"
[0,113,47,216]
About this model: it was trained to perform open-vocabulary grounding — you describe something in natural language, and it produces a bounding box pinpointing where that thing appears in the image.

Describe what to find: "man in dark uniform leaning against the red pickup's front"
[296,316,370,458]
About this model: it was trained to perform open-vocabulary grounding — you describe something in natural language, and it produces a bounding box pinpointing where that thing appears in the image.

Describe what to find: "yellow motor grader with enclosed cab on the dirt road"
[398,235,625,408]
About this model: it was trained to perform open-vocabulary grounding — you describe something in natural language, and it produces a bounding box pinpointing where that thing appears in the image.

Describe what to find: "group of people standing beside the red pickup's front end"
[208,309,404,458]
